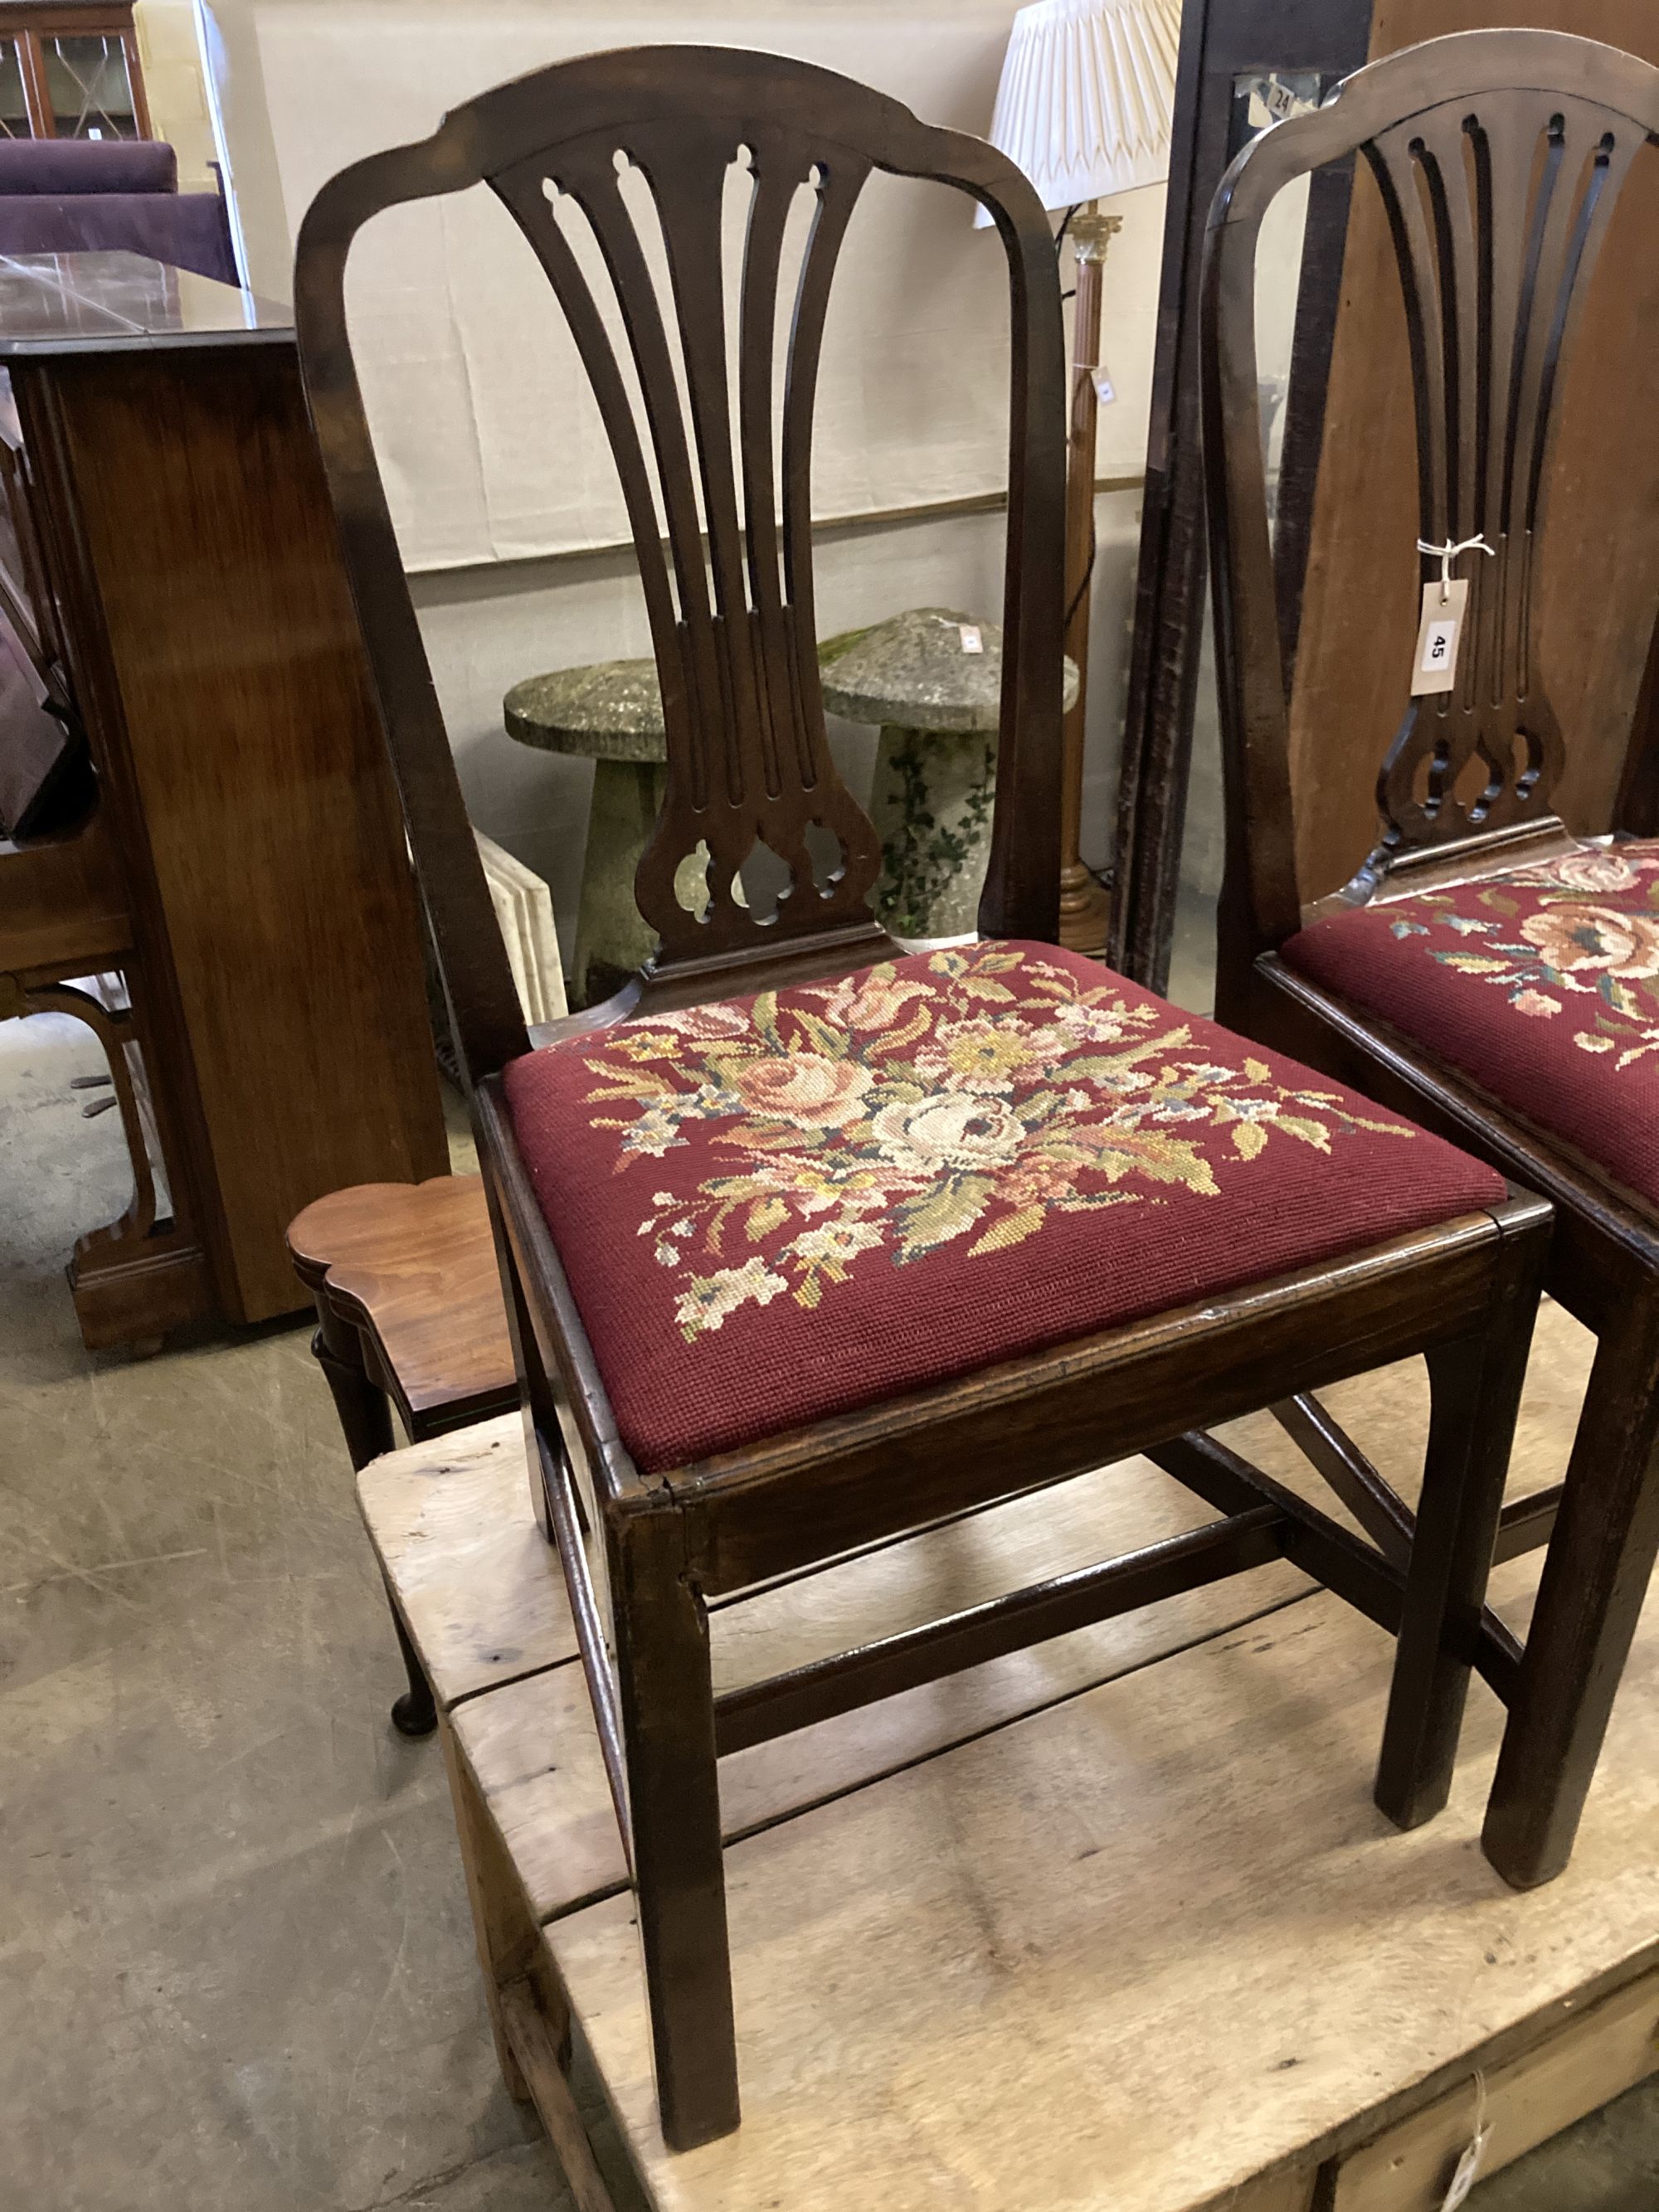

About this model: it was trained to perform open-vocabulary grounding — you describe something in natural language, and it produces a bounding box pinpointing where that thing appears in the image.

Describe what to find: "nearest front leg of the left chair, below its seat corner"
[611,1509,739,2150]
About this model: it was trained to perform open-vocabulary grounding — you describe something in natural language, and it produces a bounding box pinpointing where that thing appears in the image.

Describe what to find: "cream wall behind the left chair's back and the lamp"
[199,0,1164,942]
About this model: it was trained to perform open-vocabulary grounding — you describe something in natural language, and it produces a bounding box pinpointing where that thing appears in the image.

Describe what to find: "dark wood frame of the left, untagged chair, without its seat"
[296,46,1549,2148]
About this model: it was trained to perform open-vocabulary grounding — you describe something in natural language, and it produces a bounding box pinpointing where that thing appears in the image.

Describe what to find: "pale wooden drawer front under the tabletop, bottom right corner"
[1327,1973,1659,2212]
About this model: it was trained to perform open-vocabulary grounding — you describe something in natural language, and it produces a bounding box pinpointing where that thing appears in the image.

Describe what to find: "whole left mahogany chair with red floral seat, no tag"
[296,46,1549,2148]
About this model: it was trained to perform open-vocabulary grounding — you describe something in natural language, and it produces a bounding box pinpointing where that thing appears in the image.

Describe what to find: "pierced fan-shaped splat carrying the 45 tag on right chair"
[1363,90,1646,845]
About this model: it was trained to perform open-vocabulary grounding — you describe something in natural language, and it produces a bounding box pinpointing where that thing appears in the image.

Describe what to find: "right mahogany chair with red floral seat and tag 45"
[1204,31,1659,1887]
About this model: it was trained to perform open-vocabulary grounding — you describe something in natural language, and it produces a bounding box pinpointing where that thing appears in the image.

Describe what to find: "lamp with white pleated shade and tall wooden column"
[978,0,1181,953]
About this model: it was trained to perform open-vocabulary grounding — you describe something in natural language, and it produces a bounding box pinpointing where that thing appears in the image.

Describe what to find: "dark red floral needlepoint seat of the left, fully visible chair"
[507,942,1504,1471]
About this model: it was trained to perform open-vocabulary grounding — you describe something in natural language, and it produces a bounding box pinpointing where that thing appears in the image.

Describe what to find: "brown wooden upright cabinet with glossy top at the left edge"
[0,255,447,1345]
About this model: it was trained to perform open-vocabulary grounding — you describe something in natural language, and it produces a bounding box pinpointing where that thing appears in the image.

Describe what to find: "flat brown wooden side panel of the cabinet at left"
[45,345,447,1320]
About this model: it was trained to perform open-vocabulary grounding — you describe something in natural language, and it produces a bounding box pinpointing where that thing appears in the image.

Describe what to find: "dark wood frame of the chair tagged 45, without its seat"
[1204,31,1659,1887]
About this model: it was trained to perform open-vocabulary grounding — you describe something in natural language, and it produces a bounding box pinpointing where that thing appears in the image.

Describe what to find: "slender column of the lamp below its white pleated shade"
[1059,202,1124,953]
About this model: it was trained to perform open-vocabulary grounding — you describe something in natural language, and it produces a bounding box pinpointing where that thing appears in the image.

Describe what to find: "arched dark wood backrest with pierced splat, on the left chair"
[296,46,1064,1075]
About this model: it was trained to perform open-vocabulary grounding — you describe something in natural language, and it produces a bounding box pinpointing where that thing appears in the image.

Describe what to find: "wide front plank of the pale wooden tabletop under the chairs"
[547,1530,1659,2212]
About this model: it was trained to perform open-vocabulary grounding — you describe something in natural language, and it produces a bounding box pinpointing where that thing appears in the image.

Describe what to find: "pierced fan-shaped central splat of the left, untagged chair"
[489,131,880,958]
